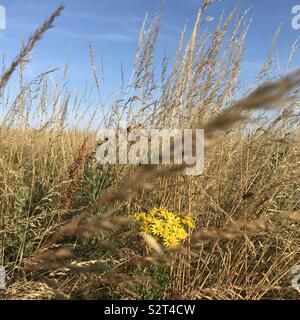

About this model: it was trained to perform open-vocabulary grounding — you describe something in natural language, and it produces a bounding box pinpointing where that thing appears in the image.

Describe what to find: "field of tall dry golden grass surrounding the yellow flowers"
[0,0,300,300]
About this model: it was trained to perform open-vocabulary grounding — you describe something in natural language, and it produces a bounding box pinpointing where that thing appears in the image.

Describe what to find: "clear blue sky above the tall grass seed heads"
[0,0,300,100]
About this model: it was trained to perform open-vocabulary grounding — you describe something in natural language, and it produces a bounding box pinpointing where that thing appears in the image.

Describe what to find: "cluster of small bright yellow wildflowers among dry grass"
[133,208,195,248]
